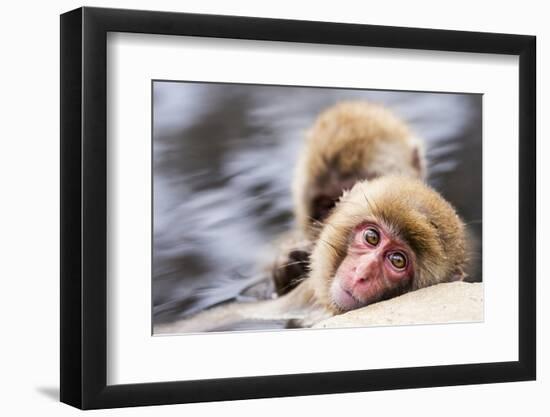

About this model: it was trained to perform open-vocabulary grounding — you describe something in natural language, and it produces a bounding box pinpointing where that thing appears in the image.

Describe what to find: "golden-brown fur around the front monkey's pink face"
[304,176,467,308]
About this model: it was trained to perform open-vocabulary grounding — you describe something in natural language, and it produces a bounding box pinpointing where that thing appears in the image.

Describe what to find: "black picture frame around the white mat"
[60,7,536,409]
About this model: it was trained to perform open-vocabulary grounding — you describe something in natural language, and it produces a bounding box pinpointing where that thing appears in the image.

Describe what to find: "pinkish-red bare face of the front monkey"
[330,223,415,312]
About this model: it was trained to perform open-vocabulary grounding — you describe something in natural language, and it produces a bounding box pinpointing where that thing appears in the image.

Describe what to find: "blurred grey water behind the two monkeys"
[152,81,482,328]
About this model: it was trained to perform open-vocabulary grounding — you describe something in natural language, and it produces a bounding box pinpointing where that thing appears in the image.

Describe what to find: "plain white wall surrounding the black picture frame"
[0,0,550,417]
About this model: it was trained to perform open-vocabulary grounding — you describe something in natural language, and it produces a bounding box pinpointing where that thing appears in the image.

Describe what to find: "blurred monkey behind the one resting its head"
[272,101,426,294]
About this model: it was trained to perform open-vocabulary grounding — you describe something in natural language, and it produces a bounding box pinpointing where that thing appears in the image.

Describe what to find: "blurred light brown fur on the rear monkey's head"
[292,101,426,239]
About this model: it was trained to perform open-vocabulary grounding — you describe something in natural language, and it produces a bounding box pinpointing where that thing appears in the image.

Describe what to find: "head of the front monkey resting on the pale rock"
[310,176,467,314]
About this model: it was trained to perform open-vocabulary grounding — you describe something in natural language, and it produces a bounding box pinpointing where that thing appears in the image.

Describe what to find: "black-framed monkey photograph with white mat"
[61,8,536,409]
